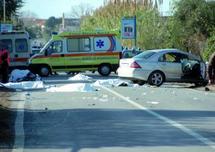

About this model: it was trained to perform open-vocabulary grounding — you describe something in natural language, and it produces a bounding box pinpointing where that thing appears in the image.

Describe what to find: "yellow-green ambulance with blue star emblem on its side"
[29,32,122,76]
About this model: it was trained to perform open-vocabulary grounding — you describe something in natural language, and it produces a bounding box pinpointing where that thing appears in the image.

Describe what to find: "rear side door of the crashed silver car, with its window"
[159,52,188,81]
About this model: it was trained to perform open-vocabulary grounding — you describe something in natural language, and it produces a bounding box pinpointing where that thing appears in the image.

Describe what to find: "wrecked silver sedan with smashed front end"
[117,49,207,86]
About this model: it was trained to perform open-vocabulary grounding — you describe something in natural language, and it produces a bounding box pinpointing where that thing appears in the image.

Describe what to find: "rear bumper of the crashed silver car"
[117,67,151,81]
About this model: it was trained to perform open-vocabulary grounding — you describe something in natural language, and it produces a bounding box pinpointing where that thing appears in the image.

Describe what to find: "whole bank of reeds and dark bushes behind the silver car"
[81,0,215,59]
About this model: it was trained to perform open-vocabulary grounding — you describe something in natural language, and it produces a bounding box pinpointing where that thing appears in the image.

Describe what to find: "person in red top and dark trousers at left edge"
[0,42,10,83]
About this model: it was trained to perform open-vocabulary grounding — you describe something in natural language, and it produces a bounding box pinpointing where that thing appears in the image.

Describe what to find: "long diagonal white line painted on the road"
[101,86,215,149]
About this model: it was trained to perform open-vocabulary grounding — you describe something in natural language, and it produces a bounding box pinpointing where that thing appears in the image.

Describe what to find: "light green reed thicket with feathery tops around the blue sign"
[81,0,165,49]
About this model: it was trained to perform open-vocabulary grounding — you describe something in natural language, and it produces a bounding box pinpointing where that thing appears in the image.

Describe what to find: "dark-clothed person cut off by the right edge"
[208,52,215,84]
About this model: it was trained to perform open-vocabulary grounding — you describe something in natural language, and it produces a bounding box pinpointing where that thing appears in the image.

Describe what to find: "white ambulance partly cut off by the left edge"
[0,31,32,69]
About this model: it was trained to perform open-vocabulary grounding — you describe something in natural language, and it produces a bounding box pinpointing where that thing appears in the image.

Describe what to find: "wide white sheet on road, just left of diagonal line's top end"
[46,83,96,92]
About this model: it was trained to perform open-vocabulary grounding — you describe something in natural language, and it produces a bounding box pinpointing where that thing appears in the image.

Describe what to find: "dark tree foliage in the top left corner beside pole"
[0,0,23,20]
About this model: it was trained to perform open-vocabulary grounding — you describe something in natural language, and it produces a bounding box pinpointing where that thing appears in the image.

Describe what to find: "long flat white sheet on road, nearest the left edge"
[4,81,45,90]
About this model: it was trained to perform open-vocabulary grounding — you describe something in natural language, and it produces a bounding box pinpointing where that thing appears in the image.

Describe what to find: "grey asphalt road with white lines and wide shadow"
[0,74,215,152]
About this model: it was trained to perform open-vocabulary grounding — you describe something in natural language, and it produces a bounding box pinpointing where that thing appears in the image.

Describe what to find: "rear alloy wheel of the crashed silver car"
[148,71,165,87]
